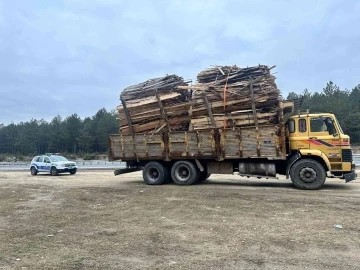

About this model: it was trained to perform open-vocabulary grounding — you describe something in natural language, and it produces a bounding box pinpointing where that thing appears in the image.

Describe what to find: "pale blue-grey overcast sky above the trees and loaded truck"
[0,0,360,124]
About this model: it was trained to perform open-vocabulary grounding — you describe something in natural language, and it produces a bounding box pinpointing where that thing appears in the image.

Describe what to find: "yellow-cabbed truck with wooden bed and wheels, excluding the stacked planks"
[108,102,357,190]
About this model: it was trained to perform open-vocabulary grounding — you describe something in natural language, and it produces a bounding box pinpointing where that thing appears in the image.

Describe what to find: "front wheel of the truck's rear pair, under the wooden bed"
[171,160,199,185]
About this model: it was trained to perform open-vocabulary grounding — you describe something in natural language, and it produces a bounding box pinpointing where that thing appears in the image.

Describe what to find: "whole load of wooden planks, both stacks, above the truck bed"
[117,65,293,135]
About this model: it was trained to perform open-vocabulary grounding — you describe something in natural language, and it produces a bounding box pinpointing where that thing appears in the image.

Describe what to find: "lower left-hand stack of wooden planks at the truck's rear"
[117,75,192,135]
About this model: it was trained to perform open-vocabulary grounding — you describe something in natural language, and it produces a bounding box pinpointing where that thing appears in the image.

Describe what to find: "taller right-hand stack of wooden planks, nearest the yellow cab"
[179,65,280,130]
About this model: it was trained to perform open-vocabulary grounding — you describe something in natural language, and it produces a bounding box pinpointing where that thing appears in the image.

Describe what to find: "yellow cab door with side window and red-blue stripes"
[309,116,342,170]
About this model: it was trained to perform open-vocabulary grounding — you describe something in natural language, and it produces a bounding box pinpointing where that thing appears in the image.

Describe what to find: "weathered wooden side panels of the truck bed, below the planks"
[109,125,286,161]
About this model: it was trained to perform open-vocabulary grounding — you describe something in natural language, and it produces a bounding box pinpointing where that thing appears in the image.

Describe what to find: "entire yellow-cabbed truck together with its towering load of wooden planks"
[108,65,357,190]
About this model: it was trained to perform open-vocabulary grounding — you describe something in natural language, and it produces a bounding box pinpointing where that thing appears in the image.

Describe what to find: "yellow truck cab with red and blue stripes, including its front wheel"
[286,112,356,188]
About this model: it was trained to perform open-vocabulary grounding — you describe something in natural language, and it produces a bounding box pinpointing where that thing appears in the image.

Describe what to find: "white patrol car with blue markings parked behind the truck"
[30,154,77,175]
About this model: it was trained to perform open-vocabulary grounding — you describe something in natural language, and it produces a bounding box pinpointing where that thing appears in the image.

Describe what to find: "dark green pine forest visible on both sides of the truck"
[0,81,360,155]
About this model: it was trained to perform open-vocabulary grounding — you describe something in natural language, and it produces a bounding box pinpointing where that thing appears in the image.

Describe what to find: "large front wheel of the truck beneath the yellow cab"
[290,159,326,189]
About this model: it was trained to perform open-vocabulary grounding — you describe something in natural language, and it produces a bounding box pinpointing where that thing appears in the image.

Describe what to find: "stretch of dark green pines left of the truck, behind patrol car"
[0,108,119,156]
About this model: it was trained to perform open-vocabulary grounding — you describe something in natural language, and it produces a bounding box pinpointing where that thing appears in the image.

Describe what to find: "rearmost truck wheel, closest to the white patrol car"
[143,161,169,185]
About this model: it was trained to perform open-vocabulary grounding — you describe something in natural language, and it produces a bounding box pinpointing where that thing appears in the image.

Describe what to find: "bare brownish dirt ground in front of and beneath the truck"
[0,171,360,269]
